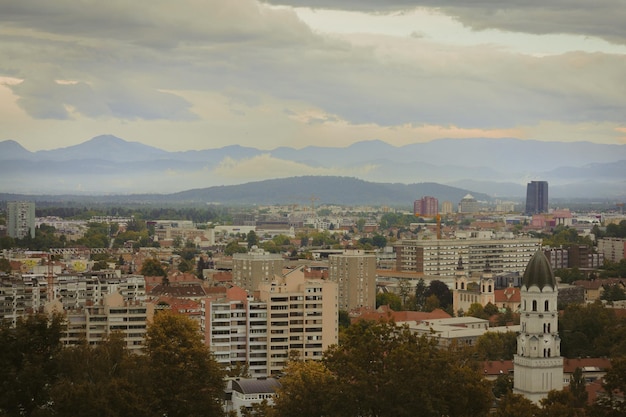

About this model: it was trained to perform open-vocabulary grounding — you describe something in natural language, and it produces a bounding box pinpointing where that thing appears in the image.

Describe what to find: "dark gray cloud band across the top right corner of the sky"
[266,0,626,44]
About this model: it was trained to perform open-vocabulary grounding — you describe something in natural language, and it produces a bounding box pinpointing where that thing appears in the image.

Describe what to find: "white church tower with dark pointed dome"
[513,250,563,403]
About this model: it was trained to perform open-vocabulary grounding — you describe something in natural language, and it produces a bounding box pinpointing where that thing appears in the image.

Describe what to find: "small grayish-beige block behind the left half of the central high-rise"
[233,247,285,292]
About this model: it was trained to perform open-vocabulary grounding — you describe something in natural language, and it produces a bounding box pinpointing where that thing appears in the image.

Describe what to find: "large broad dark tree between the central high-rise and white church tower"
[318,320,491,417]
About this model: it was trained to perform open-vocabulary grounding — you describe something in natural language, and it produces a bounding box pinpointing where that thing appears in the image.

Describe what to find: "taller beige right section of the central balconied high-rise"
[258,267,339,375]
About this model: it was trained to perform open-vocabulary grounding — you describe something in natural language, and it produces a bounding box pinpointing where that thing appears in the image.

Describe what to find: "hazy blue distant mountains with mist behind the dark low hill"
[0,135,626,198]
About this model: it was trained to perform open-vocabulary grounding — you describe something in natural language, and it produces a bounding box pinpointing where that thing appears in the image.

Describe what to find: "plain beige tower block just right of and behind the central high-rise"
[328,250,376,311]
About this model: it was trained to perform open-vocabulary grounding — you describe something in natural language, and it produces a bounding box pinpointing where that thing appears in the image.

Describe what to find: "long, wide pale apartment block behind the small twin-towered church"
[394,238,541,277]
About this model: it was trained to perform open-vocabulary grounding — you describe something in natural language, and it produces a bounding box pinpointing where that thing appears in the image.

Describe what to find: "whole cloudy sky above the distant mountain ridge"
[0,0,626,151]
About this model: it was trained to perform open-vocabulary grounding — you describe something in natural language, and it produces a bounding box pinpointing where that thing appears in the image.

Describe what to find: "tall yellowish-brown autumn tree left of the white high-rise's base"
[146,311,224,417]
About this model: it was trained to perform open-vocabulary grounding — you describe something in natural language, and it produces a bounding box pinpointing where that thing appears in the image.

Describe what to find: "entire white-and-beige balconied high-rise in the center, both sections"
[200,266,338,377]
